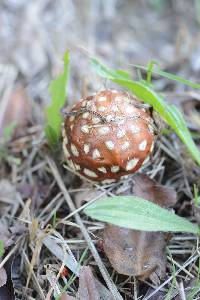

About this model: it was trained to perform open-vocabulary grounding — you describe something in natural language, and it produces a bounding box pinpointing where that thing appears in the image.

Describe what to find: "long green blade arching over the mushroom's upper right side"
[91,58,200,165]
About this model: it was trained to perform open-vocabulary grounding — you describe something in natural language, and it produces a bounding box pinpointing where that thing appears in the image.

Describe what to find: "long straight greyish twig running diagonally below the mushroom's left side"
[46,156,123,300]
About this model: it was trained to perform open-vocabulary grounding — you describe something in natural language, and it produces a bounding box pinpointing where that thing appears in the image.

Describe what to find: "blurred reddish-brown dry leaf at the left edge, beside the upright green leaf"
[0,85,31,135]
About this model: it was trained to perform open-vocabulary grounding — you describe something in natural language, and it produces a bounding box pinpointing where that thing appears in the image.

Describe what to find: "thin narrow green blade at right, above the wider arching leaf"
[131,61,200,89]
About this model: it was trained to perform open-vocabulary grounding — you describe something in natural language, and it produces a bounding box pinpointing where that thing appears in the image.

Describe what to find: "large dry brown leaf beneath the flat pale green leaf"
[104,174,176,284]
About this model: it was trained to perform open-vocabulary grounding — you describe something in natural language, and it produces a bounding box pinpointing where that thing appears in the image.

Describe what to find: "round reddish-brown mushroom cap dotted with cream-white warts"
[63,90,154,183]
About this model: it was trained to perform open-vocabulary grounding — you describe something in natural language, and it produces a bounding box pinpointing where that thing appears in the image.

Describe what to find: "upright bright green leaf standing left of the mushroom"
[45,51,70,147]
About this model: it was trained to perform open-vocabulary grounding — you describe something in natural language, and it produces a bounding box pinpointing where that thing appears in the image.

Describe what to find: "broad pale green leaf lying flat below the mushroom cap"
[84,196,199,234]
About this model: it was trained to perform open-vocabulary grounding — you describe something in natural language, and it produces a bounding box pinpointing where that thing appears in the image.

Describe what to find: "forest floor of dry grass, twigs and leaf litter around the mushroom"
[0,0,200,300]
